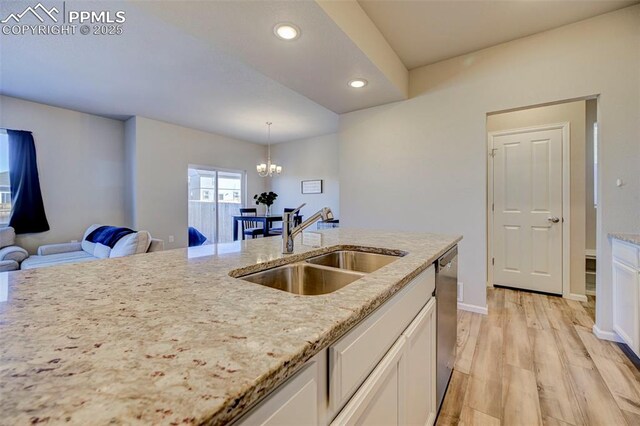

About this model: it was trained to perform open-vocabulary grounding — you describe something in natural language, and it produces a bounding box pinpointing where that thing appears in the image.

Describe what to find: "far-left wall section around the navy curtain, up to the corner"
[0,96,125,253]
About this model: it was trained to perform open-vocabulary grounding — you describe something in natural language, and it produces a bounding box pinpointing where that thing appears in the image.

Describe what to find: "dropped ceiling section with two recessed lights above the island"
[135,0,403,114]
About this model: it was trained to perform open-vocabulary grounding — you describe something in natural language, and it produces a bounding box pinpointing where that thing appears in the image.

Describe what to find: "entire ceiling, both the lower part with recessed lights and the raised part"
[0,0,634,143]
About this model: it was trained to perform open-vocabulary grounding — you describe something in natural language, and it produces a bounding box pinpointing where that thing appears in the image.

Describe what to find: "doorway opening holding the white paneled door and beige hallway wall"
[487,97,597,302]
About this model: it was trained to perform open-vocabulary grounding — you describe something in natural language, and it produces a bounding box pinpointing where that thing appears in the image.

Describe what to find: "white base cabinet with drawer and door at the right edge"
[612,240,640,356]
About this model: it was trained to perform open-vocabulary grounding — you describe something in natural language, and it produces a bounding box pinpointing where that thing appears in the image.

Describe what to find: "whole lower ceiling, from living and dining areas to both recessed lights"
[0,0,402,143]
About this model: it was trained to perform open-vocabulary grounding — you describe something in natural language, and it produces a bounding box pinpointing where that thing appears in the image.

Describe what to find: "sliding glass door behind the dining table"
[188,166,246,243]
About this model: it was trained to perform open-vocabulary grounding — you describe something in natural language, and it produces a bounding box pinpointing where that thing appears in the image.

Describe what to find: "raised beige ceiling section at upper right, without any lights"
[358,0,638,69]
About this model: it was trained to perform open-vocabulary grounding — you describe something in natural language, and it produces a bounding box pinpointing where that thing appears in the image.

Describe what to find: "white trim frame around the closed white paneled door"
[486,121,572,302]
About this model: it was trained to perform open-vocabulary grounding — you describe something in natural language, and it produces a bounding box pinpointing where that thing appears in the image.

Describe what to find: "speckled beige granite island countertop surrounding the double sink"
[0,228,461,424]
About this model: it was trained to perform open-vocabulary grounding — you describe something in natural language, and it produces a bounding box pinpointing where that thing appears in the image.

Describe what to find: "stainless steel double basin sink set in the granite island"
[239,250,398,296]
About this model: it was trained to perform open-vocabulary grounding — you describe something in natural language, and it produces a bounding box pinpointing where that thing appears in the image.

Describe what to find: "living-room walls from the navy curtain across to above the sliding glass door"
[0,96,266,253]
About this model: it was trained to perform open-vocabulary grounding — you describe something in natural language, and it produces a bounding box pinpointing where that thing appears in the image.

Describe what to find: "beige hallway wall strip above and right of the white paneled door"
[487,101,586,295]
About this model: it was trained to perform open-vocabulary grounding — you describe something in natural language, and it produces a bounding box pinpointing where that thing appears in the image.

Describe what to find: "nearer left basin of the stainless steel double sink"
[241,262,364,296]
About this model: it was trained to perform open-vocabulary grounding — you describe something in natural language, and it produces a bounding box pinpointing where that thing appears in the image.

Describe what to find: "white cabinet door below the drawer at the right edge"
[613,260,640,354]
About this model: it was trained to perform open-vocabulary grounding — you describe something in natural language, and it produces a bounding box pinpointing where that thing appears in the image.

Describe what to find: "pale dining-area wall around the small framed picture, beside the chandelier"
[268,134,340,218]
